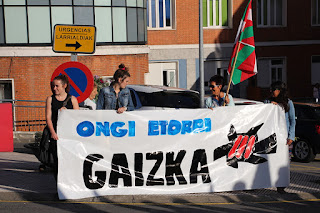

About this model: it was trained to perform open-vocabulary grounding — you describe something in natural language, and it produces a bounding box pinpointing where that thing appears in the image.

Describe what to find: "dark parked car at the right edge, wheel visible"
[292,102,320,162]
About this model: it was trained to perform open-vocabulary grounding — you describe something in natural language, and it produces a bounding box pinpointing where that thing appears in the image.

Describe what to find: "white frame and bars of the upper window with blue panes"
[147,0,176,30]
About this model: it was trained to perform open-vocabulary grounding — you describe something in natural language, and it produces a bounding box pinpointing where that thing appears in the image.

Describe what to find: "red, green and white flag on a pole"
[228,0,257,84]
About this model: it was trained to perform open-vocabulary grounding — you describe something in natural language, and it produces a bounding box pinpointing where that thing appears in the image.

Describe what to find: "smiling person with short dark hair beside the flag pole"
[205,75,234,109]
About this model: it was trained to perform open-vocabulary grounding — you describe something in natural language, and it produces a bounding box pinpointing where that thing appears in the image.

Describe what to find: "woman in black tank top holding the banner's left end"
[46,75,79,178]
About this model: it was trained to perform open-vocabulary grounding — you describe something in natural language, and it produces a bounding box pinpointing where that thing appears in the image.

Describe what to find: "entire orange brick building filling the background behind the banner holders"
[0,0,320,103]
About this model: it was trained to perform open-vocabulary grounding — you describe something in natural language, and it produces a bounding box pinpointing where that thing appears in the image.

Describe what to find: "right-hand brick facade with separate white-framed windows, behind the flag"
[145,0,320,100]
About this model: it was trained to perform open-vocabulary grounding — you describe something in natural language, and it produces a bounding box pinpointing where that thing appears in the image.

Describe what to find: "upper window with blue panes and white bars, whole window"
[147,0,175,29]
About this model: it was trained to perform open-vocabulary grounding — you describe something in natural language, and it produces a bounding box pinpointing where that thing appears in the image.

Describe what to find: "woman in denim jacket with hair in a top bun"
[97,64,134,113]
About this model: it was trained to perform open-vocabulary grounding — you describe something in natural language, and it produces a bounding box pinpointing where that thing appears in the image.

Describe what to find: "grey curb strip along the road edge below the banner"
[0,190,320,205]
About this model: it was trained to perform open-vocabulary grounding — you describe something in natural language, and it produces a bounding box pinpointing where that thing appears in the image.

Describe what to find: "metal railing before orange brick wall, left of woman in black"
[0,99,46,132]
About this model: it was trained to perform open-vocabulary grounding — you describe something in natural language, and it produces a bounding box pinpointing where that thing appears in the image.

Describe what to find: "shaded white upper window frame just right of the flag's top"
[257,0,287,28]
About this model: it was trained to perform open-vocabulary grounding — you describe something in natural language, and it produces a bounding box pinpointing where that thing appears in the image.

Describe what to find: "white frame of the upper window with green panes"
[204,0,233,29]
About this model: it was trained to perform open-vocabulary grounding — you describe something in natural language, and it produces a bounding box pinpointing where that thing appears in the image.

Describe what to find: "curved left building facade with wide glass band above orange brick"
[0,0,149,103]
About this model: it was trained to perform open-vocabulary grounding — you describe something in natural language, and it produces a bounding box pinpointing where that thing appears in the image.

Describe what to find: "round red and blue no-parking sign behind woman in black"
[51,61,93,103]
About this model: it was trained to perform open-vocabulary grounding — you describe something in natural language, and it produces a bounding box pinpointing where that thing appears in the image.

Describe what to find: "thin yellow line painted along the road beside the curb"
[0,199,320,206]
